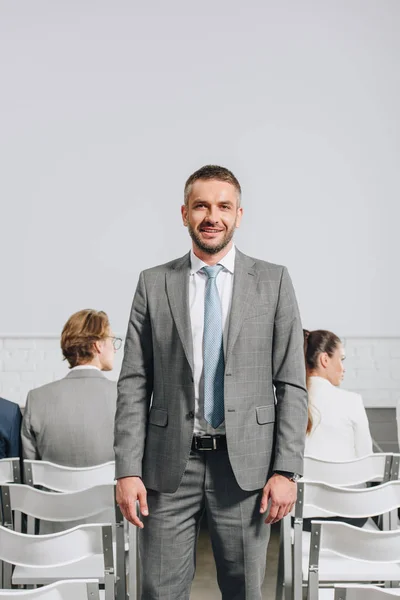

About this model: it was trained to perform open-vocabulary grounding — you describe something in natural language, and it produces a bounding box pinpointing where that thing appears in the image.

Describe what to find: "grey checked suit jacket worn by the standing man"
[114,250,307,492]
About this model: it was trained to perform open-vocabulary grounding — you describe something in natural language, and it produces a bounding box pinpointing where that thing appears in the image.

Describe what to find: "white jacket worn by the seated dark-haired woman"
[305,377,372,461]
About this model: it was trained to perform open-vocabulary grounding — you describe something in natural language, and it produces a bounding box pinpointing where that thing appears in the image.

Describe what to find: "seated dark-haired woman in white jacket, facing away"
[304,330,372,461]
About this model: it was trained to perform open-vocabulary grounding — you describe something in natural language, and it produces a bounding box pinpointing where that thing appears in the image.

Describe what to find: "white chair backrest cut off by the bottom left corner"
[0,579,100,600]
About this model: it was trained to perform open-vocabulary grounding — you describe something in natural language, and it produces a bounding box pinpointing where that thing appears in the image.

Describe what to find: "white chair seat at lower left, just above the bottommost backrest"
[12,554,104,585]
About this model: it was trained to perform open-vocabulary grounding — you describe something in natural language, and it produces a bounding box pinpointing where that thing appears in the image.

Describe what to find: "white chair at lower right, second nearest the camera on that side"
[307,524,400,600]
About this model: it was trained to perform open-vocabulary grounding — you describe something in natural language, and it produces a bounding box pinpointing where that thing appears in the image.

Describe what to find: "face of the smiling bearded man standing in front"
[181,179,243,254]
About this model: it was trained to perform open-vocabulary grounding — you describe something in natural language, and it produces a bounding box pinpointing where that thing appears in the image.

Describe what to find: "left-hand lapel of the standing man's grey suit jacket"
[166,253,193,372]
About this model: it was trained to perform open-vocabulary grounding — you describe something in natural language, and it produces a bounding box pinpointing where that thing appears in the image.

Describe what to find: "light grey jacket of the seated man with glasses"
[21,369,117,467]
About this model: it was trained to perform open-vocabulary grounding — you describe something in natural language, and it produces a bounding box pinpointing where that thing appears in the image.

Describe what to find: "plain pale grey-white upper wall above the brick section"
[0,0,400,337]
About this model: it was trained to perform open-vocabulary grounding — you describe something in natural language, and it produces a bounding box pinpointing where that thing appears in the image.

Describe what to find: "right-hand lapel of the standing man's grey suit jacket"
[225,248,257,363]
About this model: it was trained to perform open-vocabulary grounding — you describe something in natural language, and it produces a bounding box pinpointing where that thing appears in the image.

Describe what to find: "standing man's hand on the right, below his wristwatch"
[260,473,297,525]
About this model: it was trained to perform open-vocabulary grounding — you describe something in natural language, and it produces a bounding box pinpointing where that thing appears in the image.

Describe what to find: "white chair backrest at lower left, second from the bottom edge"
[0,523,114,569]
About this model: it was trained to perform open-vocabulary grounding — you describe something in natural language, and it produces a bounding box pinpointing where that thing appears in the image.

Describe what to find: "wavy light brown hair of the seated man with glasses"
[61,308,110,369]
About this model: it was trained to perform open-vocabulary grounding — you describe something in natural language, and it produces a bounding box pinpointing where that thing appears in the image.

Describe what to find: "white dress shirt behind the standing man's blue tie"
[189,246,236,435]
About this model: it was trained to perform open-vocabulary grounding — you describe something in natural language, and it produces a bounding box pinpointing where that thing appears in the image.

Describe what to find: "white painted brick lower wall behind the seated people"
[0,336,400,407]
